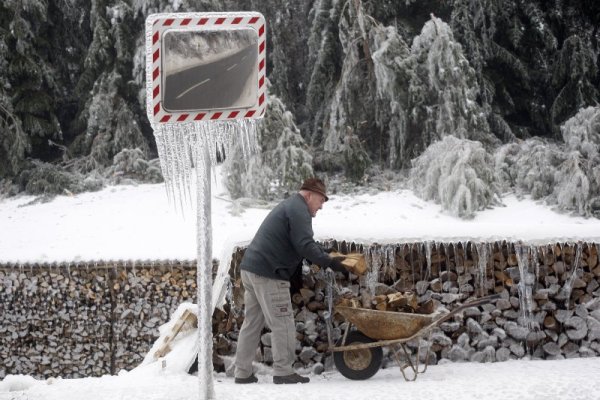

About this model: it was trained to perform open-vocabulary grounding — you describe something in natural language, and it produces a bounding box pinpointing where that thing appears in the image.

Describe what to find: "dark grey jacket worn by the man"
[240,193,331,280]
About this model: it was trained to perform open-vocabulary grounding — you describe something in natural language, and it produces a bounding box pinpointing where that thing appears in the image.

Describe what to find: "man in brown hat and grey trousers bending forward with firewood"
[235,178,345,384]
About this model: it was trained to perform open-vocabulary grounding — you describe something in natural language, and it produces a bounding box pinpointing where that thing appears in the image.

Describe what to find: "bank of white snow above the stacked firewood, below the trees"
[0,168,600,262]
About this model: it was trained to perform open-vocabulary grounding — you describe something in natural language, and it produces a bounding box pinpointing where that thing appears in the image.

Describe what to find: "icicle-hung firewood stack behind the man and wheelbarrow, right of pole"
[218,241,600,373]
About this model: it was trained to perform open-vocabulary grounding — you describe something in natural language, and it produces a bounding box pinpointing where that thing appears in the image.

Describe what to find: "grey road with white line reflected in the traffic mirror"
[163,45,258,112]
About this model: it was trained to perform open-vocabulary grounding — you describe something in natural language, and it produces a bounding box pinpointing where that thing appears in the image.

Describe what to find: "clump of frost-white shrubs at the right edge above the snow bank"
[495,107,600,217]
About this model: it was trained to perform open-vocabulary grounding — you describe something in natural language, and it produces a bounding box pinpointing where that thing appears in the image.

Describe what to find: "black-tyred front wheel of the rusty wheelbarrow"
[333,331,383,380]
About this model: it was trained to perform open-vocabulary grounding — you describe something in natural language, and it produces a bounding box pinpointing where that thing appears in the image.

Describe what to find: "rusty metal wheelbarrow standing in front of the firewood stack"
[330,294,500,381]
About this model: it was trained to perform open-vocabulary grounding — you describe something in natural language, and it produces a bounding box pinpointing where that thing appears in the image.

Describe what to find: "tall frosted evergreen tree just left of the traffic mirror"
[70,0,148,171]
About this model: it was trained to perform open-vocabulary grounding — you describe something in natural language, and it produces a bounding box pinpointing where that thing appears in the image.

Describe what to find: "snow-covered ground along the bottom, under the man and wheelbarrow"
[0,358,600,400]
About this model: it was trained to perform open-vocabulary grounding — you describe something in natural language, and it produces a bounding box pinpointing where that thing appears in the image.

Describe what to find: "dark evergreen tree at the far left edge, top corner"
[0,0,62,177]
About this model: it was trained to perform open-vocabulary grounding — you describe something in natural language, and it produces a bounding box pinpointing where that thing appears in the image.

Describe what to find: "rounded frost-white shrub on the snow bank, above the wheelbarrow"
[409,136,499,218]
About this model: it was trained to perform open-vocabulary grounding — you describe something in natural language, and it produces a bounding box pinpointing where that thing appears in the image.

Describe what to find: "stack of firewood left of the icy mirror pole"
[0,262,196,378]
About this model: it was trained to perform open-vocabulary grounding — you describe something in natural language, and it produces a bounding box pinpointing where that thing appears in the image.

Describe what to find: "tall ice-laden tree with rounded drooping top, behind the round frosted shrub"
[400,17,496,160]
